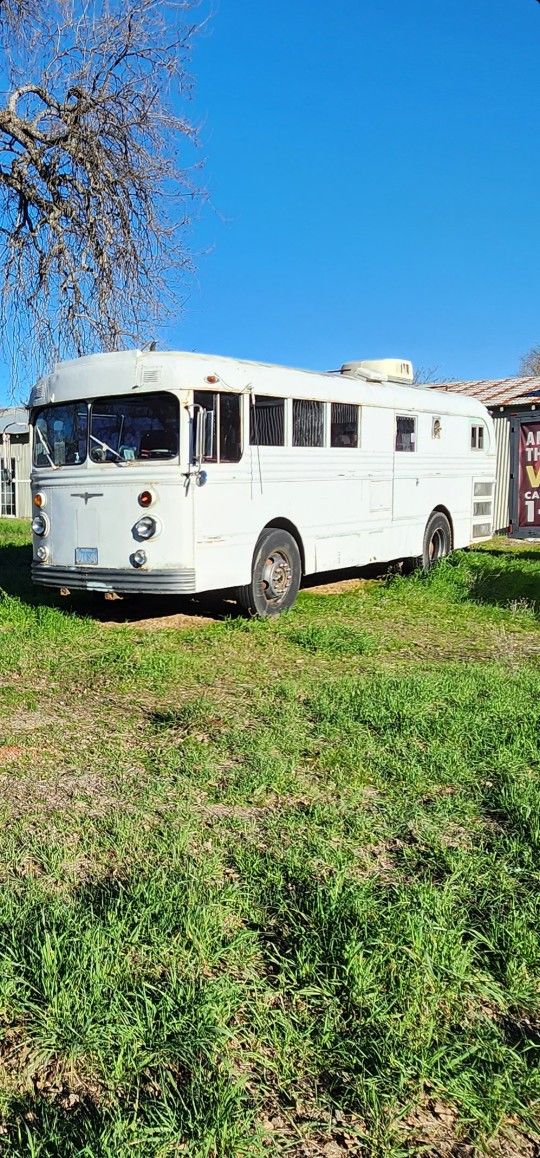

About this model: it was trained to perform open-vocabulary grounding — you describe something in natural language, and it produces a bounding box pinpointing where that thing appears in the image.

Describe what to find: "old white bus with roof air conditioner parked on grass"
[30,351,495,616]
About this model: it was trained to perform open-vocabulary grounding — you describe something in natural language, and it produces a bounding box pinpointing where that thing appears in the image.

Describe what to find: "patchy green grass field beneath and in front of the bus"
[0,521,540,1158]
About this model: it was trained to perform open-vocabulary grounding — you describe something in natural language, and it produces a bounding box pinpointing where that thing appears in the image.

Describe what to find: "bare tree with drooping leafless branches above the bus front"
[0,0,198,391]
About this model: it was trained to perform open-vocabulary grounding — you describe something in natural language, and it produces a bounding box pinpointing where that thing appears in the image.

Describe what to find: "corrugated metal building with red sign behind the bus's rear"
[431,378,540,538]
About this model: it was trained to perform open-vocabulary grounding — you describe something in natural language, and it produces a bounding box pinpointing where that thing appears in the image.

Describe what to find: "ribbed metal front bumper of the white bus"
[31,563,196,595]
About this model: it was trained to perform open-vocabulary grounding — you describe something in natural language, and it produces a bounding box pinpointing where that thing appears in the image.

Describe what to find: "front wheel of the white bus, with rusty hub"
[236,527,301,620]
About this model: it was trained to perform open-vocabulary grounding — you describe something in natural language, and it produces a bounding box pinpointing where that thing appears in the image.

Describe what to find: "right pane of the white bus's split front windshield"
[89,393,180,462]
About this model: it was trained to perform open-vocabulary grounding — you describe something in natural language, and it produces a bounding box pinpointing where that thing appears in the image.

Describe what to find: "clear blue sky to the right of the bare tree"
[166,0,540,378]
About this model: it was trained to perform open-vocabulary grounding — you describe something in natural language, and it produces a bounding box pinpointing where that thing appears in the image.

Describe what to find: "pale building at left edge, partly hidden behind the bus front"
[0,406,31,519]
